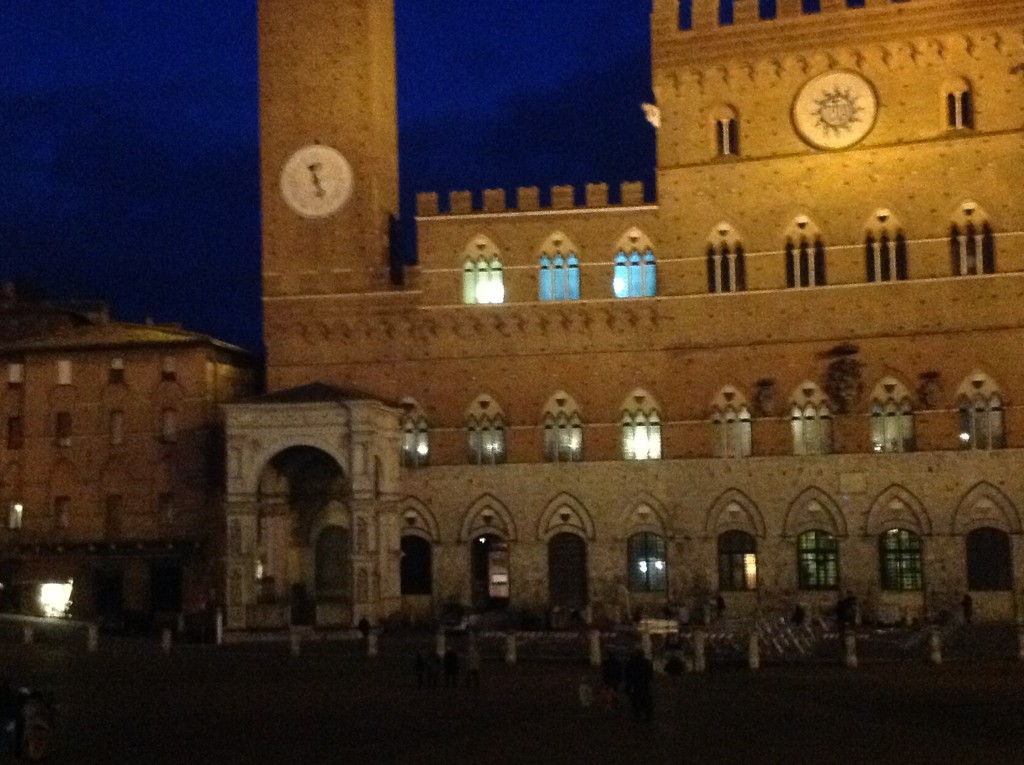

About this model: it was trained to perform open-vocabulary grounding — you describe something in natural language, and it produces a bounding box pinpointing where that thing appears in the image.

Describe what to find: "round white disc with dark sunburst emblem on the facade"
[793,72,879,148]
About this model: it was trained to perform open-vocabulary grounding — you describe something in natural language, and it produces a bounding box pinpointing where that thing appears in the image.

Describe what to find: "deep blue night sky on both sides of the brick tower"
[0,0,654,349]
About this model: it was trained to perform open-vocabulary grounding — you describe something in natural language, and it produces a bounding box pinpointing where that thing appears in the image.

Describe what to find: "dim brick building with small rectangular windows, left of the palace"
[0,286,255,628]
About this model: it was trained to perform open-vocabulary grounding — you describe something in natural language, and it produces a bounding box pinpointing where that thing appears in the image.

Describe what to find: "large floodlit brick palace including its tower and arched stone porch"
[226,0,1024,630]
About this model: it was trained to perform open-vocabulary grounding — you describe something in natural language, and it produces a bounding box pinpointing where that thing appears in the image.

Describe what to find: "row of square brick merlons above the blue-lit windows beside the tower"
[416,181,646,218]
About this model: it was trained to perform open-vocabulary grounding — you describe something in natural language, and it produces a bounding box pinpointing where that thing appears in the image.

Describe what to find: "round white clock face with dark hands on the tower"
[281,143,353,218]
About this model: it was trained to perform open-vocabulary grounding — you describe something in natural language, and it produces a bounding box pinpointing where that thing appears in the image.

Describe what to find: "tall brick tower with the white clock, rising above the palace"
[259,0,398,319]
